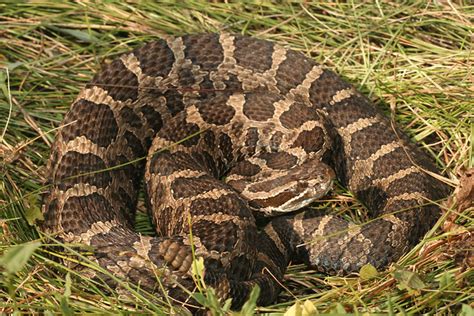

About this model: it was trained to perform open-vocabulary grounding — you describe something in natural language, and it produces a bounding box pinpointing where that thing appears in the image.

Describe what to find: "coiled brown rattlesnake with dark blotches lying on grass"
[42,33,447,308]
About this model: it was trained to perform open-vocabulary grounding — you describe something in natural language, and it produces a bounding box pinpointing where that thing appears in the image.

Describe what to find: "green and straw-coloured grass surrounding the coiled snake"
[0,0,474,315]
